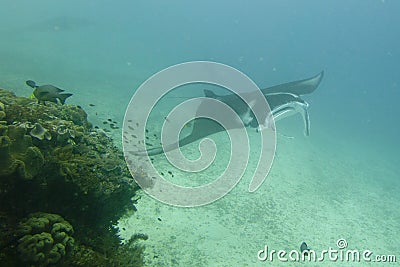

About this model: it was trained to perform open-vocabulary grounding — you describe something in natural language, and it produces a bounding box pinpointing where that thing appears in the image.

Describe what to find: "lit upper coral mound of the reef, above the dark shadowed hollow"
[0,89,137,211]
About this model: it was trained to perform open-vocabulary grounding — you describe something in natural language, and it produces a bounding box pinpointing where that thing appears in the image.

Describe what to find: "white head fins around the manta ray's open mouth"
[272,101,310,136]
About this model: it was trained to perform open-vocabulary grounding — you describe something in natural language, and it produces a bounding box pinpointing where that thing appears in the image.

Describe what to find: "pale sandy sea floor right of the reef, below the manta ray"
[118,120,400,266]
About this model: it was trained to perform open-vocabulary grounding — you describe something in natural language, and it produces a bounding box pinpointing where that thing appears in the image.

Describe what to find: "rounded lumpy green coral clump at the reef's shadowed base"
[17,212,74,266]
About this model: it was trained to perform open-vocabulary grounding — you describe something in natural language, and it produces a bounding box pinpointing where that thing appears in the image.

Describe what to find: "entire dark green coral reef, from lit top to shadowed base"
[0,89,144,266]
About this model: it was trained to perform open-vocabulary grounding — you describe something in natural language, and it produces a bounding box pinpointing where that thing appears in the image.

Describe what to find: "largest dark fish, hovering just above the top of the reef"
[25,80,72,105]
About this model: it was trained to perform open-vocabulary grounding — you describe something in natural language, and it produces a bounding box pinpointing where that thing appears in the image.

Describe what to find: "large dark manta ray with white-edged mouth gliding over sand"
[133,71,324,156]
